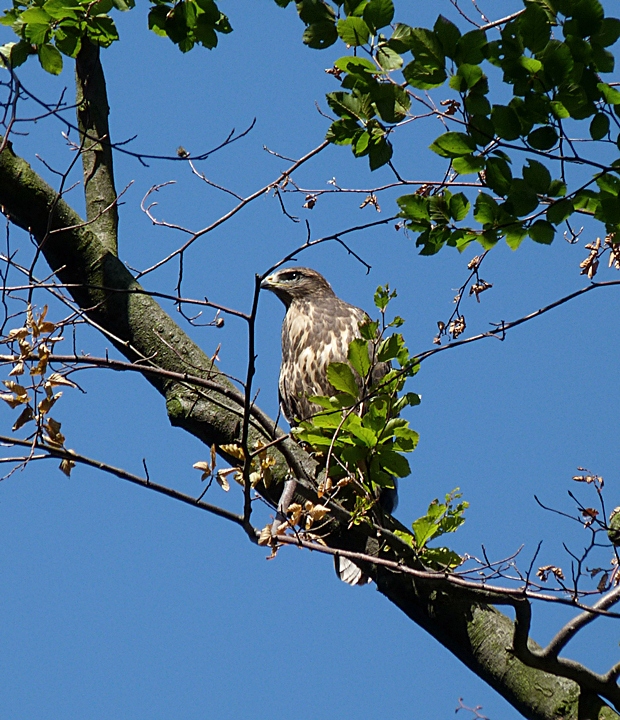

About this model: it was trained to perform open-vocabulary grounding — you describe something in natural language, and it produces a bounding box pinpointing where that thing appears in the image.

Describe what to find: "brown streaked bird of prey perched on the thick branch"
[261,267,397,585]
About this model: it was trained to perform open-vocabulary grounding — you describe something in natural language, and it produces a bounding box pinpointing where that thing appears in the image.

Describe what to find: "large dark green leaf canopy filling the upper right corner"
[276,0,620,254]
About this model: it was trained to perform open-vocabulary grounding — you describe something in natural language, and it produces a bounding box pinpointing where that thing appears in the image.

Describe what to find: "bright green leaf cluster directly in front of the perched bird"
[294,288,420,521]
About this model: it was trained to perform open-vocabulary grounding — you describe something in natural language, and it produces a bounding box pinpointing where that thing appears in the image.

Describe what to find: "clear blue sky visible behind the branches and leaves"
[0,0,620,720]
